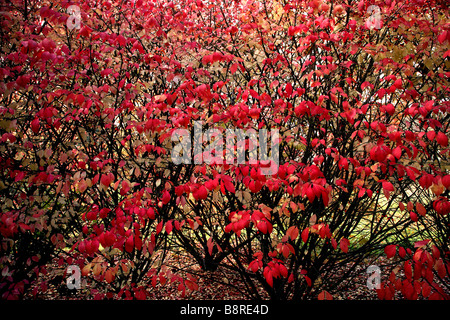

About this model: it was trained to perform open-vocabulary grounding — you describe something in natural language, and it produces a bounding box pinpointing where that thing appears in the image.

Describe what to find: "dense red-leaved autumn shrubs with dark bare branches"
[0,0,450,300]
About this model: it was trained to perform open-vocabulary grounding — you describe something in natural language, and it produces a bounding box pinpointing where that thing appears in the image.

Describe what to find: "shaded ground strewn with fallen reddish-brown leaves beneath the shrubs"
[25,254,377,300]
